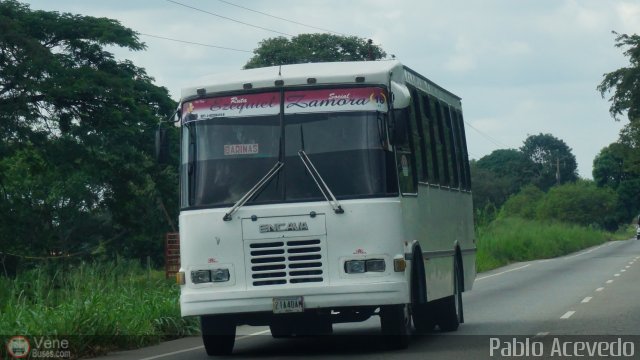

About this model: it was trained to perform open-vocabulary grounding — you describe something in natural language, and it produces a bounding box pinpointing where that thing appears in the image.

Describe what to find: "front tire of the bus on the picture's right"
[380,304,411,349]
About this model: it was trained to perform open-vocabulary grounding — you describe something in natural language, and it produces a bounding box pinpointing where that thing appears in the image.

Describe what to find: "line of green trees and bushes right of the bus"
[471,34,640,230]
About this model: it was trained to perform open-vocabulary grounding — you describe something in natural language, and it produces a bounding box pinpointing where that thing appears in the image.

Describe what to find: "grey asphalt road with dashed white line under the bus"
[100,239,640,360]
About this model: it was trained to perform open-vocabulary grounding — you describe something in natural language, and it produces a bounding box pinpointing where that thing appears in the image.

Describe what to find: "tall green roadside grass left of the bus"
[0,260,199,357]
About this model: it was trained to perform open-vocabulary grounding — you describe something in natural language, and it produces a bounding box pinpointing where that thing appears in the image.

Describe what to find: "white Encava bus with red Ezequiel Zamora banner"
[178,61,475,355]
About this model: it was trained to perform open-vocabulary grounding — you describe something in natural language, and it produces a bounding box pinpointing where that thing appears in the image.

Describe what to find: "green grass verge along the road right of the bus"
[476,218,635,272]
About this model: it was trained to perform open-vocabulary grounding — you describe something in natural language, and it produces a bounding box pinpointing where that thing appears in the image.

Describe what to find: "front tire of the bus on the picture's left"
[200,315,236,356]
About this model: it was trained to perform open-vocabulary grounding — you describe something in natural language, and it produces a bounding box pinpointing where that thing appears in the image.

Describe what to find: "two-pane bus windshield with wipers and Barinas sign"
[181,111,398,208]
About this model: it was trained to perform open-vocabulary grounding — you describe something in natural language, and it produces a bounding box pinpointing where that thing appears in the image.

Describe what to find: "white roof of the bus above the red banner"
[181,60,460,104]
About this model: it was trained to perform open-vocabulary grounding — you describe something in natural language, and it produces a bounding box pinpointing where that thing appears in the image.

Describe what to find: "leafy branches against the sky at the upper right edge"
[597,31,640,122]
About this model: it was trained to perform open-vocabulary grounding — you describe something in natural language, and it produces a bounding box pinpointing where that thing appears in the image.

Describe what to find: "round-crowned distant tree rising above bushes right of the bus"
[520,133,578,191]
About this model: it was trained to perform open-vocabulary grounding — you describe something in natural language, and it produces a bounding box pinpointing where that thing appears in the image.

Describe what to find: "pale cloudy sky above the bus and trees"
[23,0,640,178]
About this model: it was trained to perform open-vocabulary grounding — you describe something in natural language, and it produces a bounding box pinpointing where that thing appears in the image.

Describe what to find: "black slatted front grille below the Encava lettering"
[247,239,324,286]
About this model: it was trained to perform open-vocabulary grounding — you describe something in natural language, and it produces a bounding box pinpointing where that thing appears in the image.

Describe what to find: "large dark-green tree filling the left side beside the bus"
[0,0,177,268]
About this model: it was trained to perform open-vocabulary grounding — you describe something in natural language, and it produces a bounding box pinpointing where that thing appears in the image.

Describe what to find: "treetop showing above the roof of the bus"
[244,34,387,69]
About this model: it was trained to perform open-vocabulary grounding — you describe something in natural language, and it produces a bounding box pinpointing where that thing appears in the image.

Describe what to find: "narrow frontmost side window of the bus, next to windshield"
[394,108,417,194]
